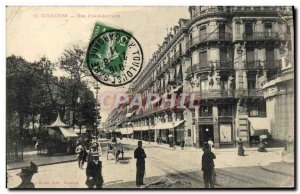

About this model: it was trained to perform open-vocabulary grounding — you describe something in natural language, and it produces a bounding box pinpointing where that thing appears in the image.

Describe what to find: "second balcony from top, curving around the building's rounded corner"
[186,32,232,50]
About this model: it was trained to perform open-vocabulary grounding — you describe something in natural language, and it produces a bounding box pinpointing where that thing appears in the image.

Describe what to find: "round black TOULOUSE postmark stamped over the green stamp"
[87,30,143,87]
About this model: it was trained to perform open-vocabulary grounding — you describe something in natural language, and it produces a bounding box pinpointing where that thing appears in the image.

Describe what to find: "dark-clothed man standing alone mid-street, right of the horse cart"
[134,141,147,187]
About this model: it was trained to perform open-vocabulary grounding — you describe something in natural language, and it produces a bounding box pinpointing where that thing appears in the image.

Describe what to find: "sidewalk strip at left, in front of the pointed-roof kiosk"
[6,151,77,170]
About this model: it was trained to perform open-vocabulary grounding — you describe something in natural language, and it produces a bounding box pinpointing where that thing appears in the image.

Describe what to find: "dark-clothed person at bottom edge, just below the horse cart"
[85,152,104,189]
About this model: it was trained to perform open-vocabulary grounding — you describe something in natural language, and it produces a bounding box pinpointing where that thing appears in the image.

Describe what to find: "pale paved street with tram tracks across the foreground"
[8,142,293,188]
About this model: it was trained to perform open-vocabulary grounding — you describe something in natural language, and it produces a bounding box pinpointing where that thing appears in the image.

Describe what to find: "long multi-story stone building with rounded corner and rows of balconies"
[103,6,293,148]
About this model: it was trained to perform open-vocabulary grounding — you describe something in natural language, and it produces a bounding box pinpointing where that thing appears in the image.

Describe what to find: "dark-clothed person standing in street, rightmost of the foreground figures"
[201,143,216,188]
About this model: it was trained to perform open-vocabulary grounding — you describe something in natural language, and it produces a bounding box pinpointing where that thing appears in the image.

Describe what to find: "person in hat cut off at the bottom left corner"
[16,162,38,189]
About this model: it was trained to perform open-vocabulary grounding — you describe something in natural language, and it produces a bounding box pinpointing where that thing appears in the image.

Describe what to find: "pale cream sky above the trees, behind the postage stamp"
[6,6,189,121]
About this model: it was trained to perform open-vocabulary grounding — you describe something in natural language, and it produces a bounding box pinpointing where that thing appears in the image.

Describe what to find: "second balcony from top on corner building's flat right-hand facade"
[243,32,280,41]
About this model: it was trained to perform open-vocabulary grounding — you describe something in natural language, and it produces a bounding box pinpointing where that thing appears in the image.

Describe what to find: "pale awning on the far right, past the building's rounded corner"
[248,118,271,136]
